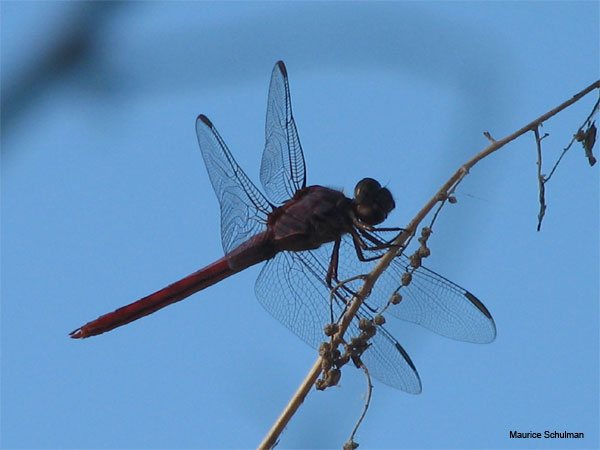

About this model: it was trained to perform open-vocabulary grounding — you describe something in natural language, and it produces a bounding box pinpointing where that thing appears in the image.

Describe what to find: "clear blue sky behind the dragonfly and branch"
[0,2,599,448]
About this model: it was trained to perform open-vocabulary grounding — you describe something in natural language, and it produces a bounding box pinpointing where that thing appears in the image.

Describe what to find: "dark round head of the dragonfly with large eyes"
[352,178,396,225]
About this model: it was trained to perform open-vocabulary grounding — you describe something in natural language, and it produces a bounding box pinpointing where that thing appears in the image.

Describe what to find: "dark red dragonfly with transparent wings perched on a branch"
[70,61,496,394]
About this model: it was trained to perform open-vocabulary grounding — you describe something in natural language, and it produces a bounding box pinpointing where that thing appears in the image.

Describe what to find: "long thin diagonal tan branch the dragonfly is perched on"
[258,80,600,449]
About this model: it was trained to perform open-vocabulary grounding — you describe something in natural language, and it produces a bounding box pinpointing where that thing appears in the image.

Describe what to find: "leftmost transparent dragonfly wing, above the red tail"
[196,115,273,253]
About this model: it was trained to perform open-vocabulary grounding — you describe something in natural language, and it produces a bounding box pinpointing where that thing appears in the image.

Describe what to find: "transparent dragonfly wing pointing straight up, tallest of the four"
[260,61,306,204]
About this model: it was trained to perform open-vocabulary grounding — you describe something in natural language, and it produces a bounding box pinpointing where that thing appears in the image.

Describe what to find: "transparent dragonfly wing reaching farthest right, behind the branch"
[338,234,496,344]
